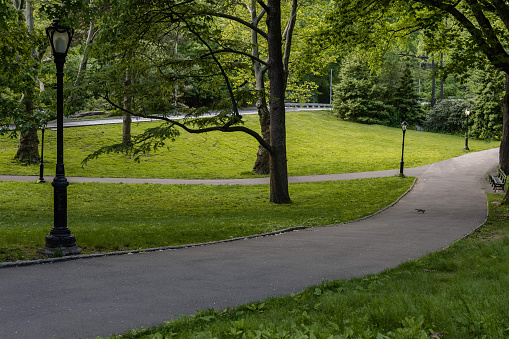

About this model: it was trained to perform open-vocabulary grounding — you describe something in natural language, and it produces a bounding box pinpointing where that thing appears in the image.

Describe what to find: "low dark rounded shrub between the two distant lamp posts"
[424,99,473,134]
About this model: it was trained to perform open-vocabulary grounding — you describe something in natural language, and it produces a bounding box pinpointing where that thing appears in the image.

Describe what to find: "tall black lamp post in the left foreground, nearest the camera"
[44,19,81,255]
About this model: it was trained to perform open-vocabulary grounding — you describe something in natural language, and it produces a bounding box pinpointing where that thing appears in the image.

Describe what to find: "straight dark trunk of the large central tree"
[267,0,291,204]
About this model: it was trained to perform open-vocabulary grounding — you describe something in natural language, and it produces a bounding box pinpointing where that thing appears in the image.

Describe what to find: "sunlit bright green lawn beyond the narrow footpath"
[0,111,500,179]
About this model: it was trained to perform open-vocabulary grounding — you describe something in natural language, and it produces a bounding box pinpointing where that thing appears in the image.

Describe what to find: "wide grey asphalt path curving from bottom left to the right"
[0,149,498,339]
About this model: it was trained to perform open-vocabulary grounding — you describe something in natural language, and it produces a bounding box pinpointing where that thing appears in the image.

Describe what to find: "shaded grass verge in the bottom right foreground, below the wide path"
[101,194,509,339]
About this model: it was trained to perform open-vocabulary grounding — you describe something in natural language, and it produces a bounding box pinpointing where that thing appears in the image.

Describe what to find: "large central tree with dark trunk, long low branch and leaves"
[82,0,290,204]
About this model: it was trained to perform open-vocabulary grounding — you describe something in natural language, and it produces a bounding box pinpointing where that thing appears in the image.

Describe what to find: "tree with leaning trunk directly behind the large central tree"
[217,0,335,174]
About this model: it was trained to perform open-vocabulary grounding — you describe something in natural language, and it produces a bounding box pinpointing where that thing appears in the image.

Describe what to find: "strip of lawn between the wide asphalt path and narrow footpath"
[0,177,413,261]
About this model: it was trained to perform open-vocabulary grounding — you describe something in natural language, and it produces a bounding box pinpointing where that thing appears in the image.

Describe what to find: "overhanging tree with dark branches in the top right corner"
[324,0,509,203]
